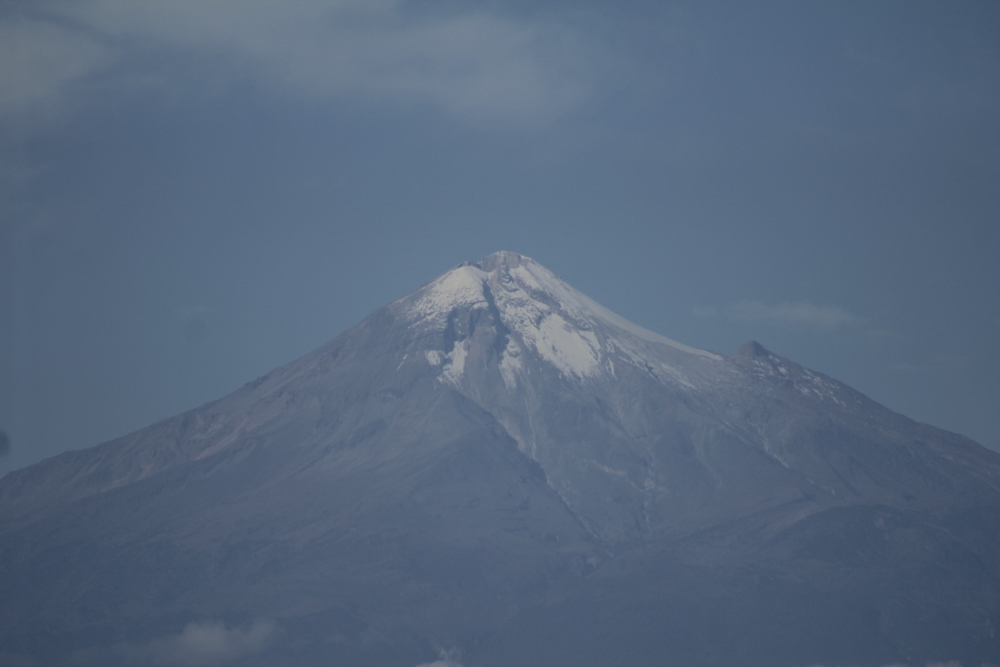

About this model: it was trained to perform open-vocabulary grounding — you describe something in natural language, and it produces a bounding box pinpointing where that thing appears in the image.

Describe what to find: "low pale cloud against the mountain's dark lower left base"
[115,621,276,667]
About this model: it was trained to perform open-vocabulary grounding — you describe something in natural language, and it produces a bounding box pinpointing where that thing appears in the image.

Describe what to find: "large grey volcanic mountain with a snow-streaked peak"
[0,253,1000,667]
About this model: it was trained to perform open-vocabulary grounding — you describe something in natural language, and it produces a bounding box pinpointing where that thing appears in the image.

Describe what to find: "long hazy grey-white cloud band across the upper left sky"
[0,0,596,130]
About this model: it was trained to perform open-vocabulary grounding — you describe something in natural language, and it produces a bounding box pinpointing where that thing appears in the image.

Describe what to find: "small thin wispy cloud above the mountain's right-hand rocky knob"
[694,299,868,332]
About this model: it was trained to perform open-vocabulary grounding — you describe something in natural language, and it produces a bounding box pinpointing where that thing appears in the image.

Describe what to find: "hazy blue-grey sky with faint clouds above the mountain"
[0,0,1000,474]
